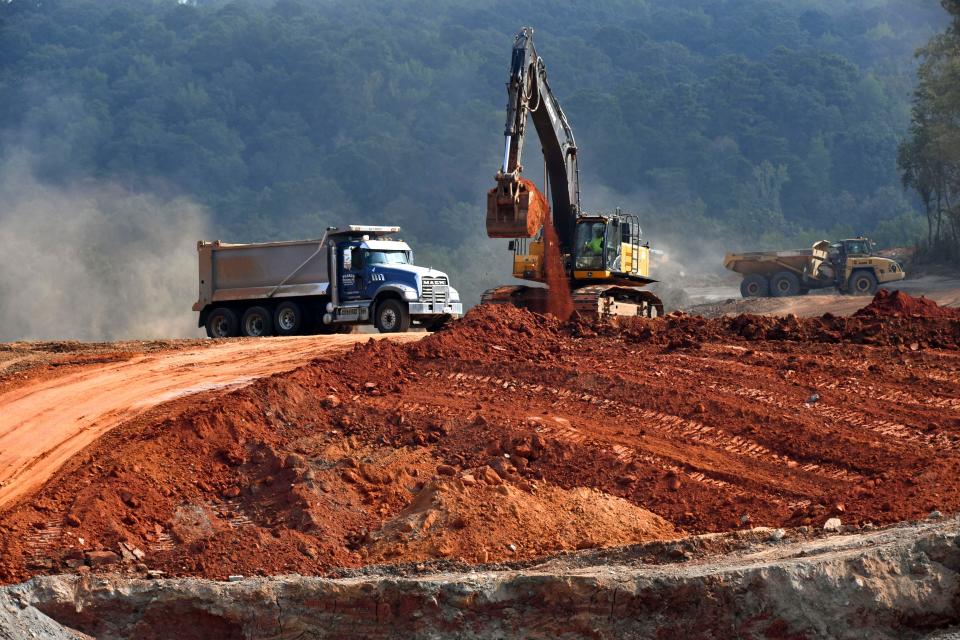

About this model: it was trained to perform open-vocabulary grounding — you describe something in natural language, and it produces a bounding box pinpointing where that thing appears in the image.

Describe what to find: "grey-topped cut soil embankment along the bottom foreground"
[0,519,960,640]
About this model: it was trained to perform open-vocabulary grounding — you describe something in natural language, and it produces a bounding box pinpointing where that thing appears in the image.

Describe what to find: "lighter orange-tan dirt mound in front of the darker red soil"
[365,467,678,563]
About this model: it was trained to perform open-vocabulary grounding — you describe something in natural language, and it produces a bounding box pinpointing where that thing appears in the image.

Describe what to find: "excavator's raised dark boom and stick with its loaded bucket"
[487,27,580,251]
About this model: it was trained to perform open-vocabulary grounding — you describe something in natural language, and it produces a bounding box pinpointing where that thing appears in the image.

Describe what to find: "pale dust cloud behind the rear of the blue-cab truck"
[0,160,208,342]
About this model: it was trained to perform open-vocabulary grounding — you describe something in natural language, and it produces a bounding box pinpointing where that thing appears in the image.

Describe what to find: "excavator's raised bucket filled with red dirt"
[487,173,550,238]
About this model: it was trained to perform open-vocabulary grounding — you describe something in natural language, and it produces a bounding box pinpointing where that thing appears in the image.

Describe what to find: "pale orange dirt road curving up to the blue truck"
[0,333,424,509]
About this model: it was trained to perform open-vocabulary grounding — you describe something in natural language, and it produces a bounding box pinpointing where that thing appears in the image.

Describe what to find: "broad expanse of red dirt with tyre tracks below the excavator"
[0,306,960,581]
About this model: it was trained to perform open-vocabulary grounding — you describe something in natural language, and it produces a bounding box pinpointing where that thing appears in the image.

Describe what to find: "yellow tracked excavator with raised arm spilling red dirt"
[481,27,663,318]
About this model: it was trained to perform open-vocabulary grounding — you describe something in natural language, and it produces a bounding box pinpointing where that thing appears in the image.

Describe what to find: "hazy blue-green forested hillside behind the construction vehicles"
[0,0,947,300]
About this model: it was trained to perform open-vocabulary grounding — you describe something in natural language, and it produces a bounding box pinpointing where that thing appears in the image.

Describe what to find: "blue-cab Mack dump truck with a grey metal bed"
[193,225,463,338]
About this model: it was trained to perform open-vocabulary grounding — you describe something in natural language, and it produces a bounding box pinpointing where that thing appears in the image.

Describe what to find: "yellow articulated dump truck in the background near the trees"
[723,238,906,298]
